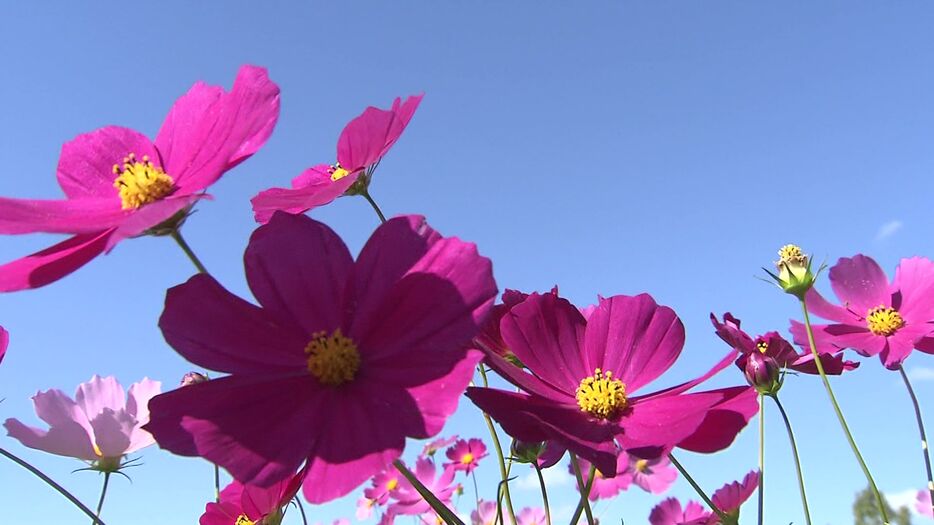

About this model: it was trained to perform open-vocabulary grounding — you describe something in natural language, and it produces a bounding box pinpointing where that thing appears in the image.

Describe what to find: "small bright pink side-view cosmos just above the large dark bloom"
[251,95,423,224]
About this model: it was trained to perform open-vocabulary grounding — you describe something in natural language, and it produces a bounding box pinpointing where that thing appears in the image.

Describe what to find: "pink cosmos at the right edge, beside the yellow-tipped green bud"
[791,255,934,370]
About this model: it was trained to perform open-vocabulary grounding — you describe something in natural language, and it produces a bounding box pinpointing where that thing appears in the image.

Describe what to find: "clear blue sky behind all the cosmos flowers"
[0,1,934,525]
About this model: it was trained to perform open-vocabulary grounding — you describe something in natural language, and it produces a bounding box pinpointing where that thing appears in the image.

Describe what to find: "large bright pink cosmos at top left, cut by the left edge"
[0,66,279,292]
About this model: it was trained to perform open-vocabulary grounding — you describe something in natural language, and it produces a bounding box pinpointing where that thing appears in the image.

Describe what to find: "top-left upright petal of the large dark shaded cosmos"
[243,213,354,336]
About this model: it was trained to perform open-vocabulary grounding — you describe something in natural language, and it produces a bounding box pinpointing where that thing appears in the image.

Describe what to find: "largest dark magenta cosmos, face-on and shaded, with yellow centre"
[146,213,496,503]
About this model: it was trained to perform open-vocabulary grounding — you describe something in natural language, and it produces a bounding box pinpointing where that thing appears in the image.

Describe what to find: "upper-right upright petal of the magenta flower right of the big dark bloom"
[584,294,684,393]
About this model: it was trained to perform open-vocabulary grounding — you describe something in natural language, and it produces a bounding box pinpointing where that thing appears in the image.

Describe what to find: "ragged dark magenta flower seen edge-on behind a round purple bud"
[710,312,859,375]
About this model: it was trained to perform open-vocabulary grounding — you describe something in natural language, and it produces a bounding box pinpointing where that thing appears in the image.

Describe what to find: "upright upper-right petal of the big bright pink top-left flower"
[156,66,279,194]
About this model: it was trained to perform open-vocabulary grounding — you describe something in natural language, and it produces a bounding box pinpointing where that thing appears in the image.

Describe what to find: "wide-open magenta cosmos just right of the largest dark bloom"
[467,293,754,477]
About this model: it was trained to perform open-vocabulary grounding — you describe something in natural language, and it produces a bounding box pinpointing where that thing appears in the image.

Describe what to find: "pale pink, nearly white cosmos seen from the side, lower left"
[3,376,161,472]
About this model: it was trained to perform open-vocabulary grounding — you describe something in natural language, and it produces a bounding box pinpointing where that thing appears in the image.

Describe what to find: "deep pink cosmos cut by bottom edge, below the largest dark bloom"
[199,471,305,525]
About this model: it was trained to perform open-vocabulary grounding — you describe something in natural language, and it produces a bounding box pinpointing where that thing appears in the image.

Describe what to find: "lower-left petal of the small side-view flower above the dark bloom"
[250,164,361,224]
